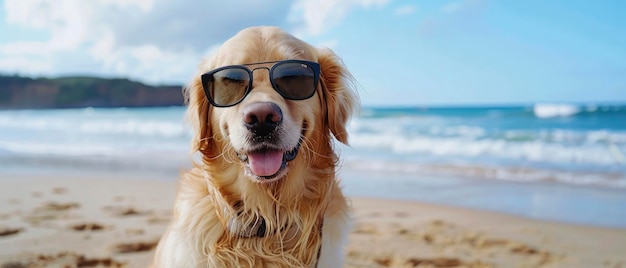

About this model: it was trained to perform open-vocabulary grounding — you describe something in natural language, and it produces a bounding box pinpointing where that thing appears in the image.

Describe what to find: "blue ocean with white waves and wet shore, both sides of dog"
[0,104,626,227]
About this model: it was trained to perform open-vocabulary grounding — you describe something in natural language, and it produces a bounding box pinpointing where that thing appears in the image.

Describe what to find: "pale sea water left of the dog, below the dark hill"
[0,107,191,179]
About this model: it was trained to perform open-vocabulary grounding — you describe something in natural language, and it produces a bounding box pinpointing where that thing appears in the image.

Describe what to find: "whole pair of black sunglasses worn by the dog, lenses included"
[201,60,320,107]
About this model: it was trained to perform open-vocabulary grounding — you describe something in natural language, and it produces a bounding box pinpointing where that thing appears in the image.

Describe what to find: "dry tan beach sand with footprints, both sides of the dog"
[0,175,626,268]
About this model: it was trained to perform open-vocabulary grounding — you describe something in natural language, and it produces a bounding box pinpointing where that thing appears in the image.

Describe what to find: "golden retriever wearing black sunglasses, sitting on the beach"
[153,26,358,268]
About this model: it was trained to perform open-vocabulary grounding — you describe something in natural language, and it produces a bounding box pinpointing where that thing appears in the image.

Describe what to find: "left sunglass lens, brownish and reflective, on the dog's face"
[209,68,250,106]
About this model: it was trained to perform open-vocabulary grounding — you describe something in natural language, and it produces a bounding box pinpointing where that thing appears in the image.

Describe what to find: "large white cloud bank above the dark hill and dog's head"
[0,0,389,83]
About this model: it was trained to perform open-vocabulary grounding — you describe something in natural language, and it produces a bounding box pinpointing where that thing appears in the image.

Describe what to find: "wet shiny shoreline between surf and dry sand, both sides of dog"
[0,163,626,228]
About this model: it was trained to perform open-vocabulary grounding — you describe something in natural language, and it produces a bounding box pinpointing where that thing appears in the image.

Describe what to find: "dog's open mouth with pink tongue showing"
[237,142,300,182]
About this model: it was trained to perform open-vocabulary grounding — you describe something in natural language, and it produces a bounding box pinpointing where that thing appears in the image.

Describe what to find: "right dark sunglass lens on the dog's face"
[272,62,315,100]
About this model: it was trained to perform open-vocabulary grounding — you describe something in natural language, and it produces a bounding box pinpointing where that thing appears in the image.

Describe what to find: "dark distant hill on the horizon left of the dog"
[0,75,183,109]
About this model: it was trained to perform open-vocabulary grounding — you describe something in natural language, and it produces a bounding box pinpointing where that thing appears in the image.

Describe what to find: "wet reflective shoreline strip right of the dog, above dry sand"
[339,169,626,228]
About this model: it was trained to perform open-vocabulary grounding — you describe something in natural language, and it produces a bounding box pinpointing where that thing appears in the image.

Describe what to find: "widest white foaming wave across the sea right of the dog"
[350,135,626,166]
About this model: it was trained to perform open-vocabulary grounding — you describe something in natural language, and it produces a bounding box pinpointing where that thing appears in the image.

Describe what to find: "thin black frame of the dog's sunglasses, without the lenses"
[200,60,320,107]
